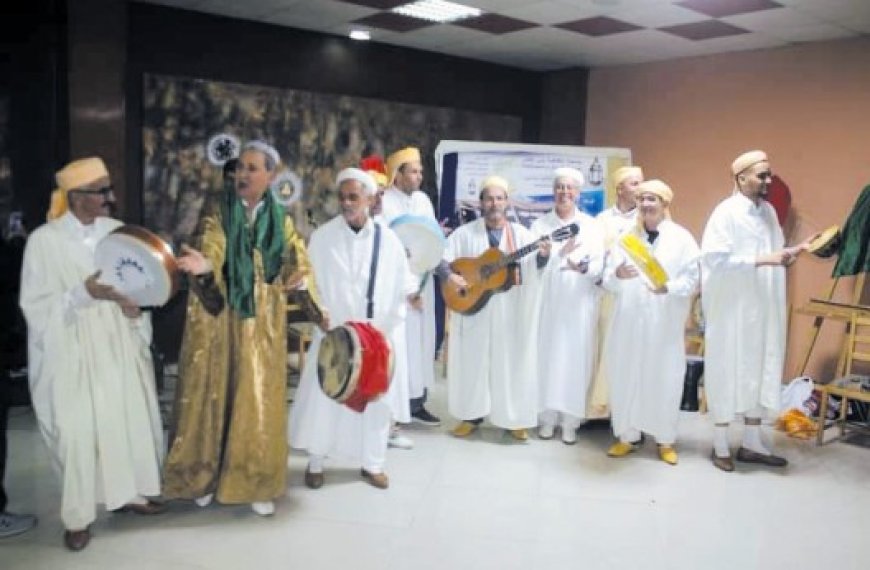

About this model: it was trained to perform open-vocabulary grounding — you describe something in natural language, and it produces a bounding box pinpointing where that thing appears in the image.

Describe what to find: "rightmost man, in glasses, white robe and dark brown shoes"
[701,150,808,472]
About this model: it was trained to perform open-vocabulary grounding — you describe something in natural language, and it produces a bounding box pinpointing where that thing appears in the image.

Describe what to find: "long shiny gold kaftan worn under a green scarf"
[163,211,315,504]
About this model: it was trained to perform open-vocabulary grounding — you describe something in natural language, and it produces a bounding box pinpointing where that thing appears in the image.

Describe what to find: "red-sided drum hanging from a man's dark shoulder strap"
[317,321,393,412]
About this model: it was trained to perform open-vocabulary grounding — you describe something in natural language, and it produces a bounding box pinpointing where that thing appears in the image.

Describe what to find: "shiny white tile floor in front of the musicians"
[0,382,870,570]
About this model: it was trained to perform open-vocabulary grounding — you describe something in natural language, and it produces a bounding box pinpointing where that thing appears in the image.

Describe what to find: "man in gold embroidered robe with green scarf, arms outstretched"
[163,141,314,516]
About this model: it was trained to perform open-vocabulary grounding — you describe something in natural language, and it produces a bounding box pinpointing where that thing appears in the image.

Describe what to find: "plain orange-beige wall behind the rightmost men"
[586,38,870,381]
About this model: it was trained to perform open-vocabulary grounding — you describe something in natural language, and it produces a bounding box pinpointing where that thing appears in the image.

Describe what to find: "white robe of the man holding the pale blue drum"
[381,187,437,398]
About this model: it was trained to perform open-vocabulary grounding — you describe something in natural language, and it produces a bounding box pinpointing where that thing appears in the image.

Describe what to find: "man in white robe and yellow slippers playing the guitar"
[439,176,550,442]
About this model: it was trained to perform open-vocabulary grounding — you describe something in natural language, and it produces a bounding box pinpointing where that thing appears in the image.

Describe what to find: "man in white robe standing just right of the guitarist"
[531,168,604,445]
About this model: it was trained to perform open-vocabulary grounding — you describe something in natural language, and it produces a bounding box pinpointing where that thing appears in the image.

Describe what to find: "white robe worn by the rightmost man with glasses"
[701,192,786,423]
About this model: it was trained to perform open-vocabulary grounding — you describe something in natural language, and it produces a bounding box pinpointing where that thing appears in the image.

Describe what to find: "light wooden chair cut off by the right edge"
[816,314,870,445]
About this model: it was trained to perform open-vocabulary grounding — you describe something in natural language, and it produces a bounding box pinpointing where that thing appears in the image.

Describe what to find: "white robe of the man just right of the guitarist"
[531,209,604,418]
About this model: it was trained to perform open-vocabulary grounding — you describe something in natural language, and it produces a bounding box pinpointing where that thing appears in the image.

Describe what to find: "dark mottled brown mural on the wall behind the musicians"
[142,75,522,245]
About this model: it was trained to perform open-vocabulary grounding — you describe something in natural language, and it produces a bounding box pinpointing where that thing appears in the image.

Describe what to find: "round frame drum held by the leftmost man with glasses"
[94,225,178,307]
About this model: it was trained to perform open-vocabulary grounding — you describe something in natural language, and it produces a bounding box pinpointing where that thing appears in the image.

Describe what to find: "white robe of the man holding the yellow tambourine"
[604,220,700,444]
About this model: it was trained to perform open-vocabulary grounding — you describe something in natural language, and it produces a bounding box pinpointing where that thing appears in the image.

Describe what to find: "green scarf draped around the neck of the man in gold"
[222,190,284,319]
